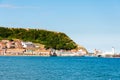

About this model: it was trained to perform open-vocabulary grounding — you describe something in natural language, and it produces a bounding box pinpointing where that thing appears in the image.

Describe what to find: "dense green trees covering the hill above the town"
[0,27,77,50]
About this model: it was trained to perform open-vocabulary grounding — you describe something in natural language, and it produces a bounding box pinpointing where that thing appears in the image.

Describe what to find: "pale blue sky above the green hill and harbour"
[0,0,120,52]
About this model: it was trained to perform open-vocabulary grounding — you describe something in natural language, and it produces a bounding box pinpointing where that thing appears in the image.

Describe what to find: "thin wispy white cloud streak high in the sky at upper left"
[0,4,39,9]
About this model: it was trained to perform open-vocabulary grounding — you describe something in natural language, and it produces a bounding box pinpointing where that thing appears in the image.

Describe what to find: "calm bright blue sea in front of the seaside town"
[0,56,120,80]
